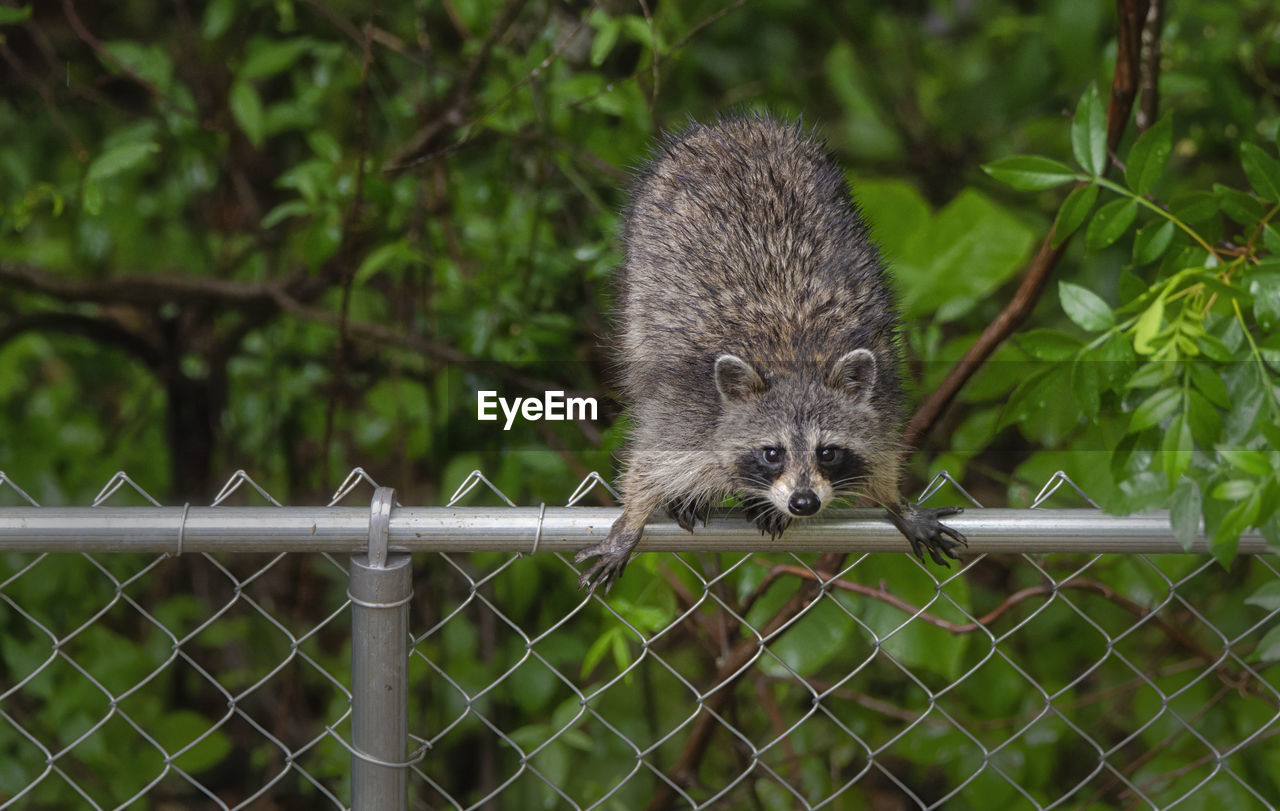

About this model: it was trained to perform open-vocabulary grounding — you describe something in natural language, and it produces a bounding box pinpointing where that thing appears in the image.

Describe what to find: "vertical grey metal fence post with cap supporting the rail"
[348,487,413,811]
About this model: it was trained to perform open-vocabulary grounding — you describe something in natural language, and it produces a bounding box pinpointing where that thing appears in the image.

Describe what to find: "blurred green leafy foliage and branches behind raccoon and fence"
[0,0,1280,807]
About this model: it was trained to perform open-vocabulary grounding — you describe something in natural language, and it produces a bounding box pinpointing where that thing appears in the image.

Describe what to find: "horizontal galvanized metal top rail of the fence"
[0,507,1267,554]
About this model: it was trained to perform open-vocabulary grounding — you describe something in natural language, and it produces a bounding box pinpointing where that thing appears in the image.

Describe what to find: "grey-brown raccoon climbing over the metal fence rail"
[575,115,965,591]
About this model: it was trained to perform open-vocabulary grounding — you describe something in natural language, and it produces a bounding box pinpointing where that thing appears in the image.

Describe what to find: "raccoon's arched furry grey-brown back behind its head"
[618,116,901,452]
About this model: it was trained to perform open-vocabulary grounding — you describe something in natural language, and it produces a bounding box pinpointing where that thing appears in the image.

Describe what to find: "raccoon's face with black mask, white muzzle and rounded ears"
[716,349,877,518]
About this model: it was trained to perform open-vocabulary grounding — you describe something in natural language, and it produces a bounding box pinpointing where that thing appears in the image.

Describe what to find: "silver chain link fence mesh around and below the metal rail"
[0,469,1280,808]
